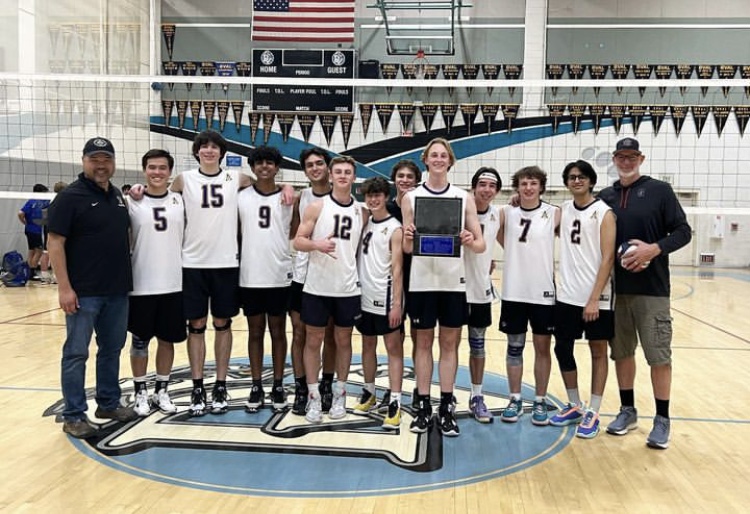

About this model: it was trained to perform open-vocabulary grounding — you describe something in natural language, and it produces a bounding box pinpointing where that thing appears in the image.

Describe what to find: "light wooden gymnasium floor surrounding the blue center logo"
[0,268,750,514]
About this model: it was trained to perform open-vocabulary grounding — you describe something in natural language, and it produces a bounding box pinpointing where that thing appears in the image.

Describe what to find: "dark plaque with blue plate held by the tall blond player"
[412,196,463,257]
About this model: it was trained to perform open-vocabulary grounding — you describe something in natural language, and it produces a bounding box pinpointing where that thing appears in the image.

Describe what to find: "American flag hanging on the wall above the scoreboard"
[252,0,354,43]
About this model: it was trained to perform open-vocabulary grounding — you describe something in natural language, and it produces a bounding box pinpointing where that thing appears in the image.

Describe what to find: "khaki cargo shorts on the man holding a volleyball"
[610,295,672,366]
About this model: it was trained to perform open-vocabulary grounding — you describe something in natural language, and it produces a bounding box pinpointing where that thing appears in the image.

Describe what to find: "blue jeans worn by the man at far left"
[61,294,128,421]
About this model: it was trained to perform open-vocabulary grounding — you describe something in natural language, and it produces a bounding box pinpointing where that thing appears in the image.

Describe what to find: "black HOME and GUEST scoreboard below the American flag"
[253,49,354,113]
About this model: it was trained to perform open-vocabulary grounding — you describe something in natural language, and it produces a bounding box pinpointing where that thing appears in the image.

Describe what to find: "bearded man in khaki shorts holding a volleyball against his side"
[599,137,692,449]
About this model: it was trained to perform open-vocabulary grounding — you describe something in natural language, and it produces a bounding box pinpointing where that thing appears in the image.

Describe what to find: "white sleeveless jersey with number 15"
[181,169,240,268]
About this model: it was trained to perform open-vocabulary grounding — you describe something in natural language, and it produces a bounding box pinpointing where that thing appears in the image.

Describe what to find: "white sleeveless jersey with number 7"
[502,201,558,305]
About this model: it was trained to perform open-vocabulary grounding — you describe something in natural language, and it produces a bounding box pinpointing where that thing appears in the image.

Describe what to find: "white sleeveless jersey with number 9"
[237,187,293,288]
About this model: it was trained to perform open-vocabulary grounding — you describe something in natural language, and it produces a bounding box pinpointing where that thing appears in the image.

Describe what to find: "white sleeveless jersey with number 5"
[128,192,185,296]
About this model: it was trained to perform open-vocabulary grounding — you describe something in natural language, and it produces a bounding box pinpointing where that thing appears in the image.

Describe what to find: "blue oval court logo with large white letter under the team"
[45,361,573,497]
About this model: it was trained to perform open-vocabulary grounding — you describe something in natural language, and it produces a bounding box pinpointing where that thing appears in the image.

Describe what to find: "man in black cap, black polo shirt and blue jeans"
[47,137,136,438]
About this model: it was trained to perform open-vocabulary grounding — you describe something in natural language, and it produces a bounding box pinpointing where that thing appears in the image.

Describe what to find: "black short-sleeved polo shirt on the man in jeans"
[49,173,133,296]
